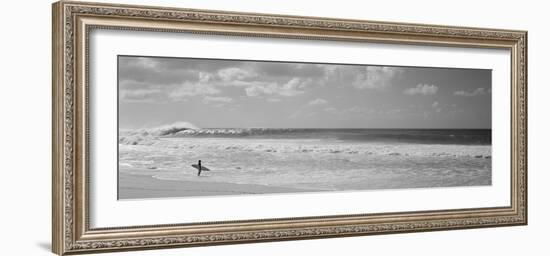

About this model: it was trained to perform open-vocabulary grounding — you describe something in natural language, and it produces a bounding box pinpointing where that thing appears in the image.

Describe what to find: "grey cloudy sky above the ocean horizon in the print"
[118,56,491,129]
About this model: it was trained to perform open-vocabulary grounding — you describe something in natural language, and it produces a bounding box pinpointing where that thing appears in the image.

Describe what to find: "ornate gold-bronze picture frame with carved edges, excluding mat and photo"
[52,1,527,255]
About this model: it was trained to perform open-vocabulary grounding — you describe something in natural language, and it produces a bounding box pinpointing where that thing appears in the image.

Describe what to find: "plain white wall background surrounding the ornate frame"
[0,0,550,255]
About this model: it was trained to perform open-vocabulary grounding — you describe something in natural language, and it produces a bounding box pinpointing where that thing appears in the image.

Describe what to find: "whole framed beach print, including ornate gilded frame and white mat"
[52,1,527,255]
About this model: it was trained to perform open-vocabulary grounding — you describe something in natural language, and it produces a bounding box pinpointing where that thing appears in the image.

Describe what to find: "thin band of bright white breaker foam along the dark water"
[121,134,491,158]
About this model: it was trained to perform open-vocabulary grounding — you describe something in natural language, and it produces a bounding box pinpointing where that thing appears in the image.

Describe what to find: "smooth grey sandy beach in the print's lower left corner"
[118,169,311,199]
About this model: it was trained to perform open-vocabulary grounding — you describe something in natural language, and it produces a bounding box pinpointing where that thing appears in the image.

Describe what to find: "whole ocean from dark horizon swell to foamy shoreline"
[119,125,491,194]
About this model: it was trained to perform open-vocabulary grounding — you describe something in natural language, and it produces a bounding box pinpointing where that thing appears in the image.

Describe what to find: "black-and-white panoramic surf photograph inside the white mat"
[118,56,492,199]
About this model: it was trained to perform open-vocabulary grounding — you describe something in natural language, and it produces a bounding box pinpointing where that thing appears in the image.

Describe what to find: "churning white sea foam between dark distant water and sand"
[119,135,491,190]
